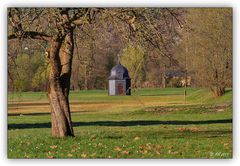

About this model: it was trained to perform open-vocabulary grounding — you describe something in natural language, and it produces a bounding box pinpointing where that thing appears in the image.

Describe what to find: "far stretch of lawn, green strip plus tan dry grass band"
[8,88,232,114]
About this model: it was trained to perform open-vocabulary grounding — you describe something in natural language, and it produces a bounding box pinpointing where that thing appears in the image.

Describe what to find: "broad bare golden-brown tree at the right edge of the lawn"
[182,8,232,97]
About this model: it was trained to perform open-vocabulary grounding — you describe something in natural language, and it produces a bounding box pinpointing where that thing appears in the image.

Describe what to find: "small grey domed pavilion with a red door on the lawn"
[108,61,131,96]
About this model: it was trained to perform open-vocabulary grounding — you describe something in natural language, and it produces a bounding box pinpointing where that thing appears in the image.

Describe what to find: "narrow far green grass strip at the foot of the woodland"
[8,88,232,102]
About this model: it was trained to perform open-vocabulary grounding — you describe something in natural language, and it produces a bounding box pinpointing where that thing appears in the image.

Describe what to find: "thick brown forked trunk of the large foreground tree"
[48,30,74,137]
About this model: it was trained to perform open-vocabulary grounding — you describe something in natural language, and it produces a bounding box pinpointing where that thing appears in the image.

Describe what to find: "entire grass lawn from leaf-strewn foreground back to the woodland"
[8,88,232,158]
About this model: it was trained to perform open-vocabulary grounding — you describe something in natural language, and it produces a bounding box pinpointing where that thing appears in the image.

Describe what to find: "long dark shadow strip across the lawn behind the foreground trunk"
[8,119,232,129]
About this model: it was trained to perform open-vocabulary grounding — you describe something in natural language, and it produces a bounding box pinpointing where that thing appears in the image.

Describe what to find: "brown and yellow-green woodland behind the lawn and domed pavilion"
[8,8,232,96]
